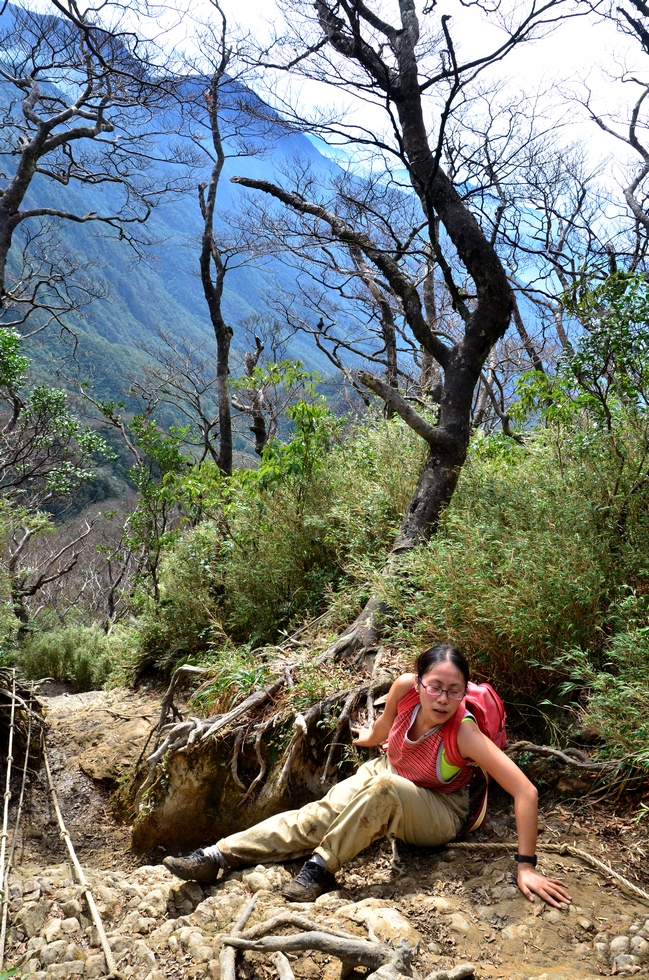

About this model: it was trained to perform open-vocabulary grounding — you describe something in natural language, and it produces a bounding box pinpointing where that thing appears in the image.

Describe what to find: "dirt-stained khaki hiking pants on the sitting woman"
[218,755,469,872]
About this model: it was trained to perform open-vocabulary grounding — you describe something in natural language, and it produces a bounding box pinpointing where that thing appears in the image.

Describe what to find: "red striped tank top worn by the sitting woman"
[388,687,473,793]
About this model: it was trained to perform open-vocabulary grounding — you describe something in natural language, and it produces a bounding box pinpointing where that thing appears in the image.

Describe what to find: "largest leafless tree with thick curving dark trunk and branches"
[223,0,596,660]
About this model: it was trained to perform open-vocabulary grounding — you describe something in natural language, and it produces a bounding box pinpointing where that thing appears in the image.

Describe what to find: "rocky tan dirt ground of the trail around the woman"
[5,691,649,980]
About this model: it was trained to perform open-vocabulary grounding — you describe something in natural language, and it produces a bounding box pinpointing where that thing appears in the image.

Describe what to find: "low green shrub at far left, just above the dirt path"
[16,623,130,692]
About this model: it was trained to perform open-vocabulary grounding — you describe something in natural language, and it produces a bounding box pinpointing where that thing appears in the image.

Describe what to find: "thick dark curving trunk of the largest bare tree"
[316,0,513,554]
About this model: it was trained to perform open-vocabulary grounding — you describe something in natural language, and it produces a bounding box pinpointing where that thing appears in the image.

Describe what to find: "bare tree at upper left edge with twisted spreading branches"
[0,0,191,333]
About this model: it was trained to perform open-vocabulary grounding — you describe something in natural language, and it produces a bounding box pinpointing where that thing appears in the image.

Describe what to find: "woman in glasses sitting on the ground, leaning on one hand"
[164,644,570,906]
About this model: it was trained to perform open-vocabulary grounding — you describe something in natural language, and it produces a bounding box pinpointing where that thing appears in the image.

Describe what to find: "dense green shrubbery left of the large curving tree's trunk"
[132,414,423,673]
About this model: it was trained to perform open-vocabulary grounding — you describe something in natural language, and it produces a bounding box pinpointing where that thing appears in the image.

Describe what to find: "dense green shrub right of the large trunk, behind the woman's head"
[375,431,611,692]
